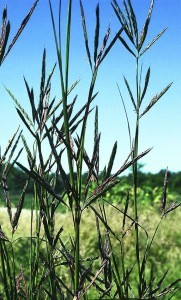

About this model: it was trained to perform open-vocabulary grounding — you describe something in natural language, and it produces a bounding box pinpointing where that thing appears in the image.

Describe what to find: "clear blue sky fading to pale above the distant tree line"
[0,0,181,172]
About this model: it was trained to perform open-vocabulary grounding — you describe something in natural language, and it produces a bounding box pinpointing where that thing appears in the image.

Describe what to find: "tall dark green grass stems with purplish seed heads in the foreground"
[0,0,180,299]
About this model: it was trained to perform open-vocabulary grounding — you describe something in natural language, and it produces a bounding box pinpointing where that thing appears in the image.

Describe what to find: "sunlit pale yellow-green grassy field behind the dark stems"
[0,206,181,300]
